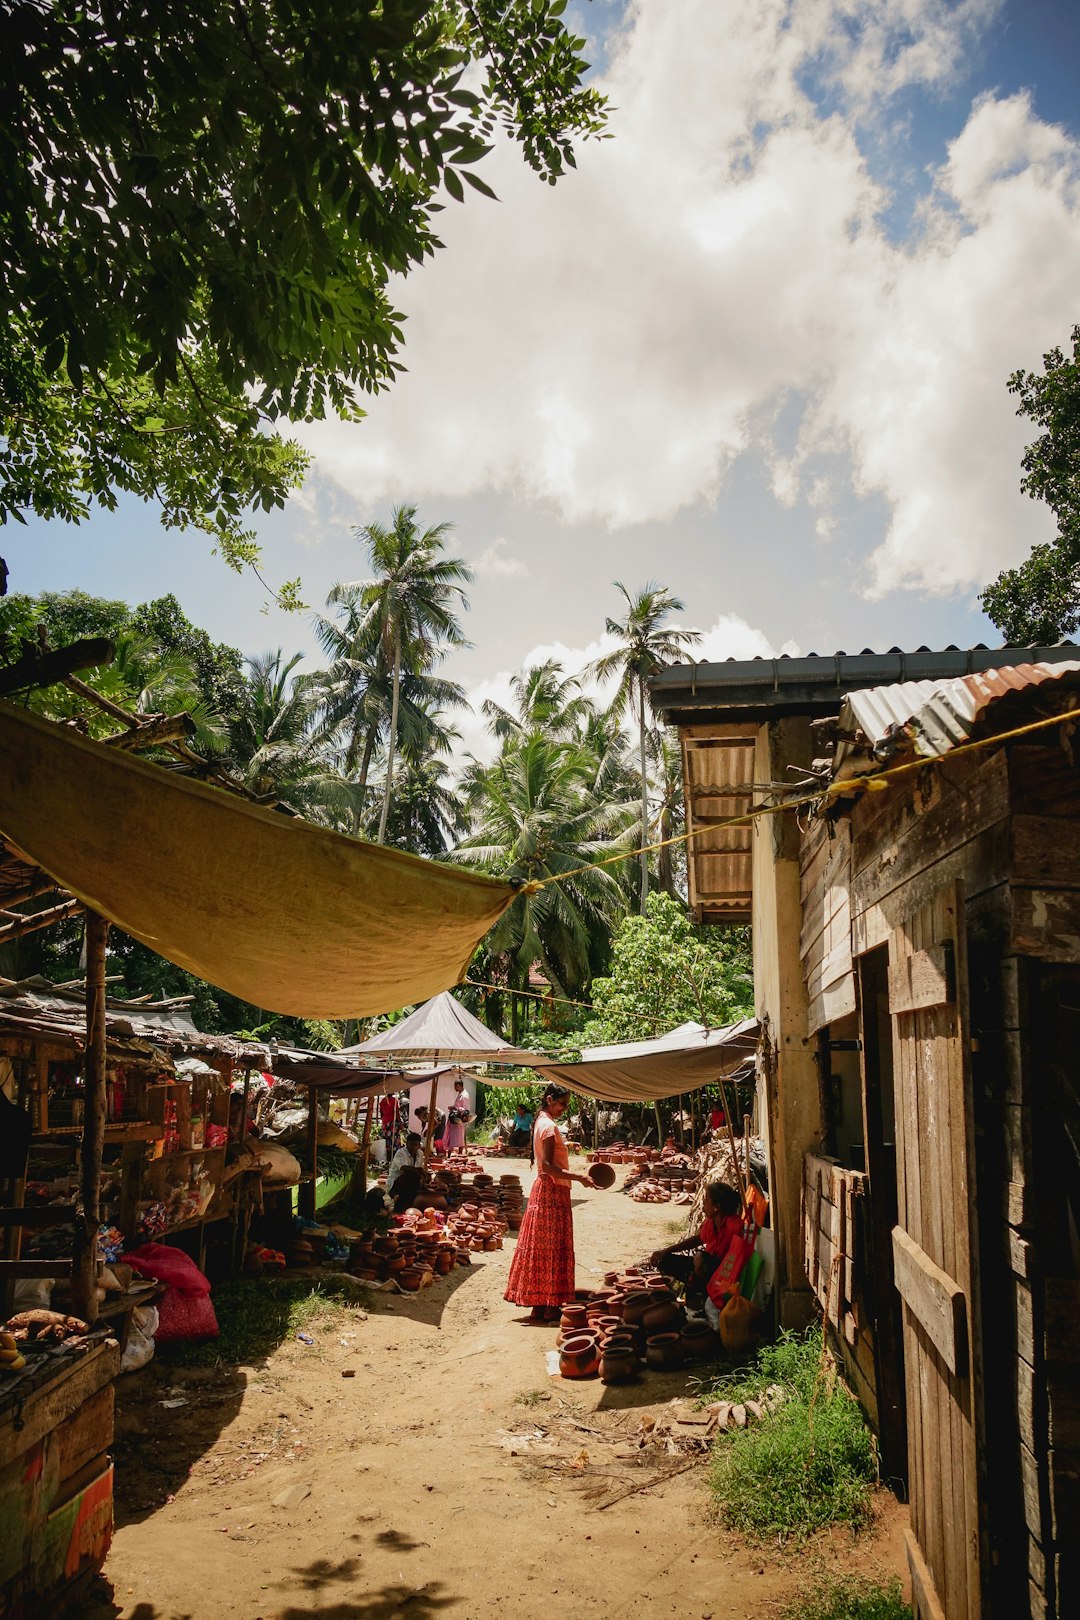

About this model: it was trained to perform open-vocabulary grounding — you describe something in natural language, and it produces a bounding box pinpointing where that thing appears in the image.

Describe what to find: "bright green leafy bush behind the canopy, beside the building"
[585,893,753,1045]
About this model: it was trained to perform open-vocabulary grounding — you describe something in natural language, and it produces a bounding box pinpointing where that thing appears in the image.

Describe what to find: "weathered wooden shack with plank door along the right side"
[661,648,1080,1620]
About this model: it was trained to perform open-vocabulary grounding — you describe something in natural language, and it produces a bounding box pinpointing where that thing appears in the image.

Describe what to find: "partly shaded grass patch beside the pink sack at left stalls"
[157,1277,368,1367]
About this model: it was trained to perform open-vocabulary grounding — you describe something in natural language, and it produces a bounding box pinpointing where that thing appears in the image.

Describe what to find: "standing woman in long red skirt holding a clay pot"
[504,1085,593,1322]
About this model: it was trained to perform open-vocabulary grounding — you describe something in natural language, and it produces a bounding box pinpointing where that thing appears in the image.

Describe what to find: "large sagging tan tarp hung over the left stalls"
[0,703,515,1017]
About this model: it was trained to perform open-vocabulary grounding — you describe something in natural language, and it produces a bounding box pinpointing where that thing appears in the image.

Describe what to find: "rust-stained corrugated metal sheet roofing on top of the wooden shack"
[834,659,1080,770]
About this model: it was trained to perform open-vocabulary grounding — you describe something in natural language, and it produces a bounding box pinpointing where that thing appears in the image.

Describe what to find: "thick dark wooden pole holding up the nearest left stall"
[71,910,108,1322]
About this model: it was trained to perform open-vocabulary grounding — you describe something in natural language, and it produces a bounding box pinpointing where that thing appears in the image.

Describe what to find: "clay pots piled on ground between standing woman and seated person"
[555,1267,716,1383]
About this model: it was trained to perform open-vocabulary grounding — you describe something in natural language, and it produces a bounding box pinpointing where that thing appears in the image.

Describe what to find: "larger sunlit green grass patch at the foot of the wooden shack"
[706,1332,887,1542]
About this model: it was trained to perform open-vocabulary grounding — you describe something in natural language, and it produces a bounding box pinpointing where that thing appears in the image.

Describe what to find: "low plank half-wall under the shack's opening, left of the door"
[803,1153,878,1429]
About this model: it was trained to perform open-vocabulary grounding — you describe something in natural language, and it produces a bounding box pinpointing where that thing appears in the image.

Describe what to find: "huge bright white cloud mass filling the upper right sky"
[301,0,1080,595]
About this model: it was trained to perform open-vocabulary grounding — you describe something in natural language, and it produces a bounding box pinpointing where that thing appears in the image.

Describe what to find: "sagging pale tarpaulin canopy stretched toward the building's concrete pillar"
[534,1017,758,1103]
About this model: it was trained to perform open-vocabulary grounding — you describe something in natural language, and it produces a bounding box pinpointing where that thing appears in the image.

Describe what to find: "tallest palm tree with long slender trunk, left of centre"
[340,505,473,842]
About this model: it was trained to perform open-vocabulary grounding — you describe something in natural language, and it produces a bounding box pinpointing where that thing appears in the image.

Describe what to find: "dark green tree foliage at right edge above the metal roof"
[980,326,1080,646]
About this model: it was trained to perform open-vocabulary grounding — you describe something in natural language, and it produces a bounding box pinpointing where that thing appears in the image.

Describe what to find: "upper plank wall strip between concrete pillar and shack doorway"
[798,816,855,1035]
